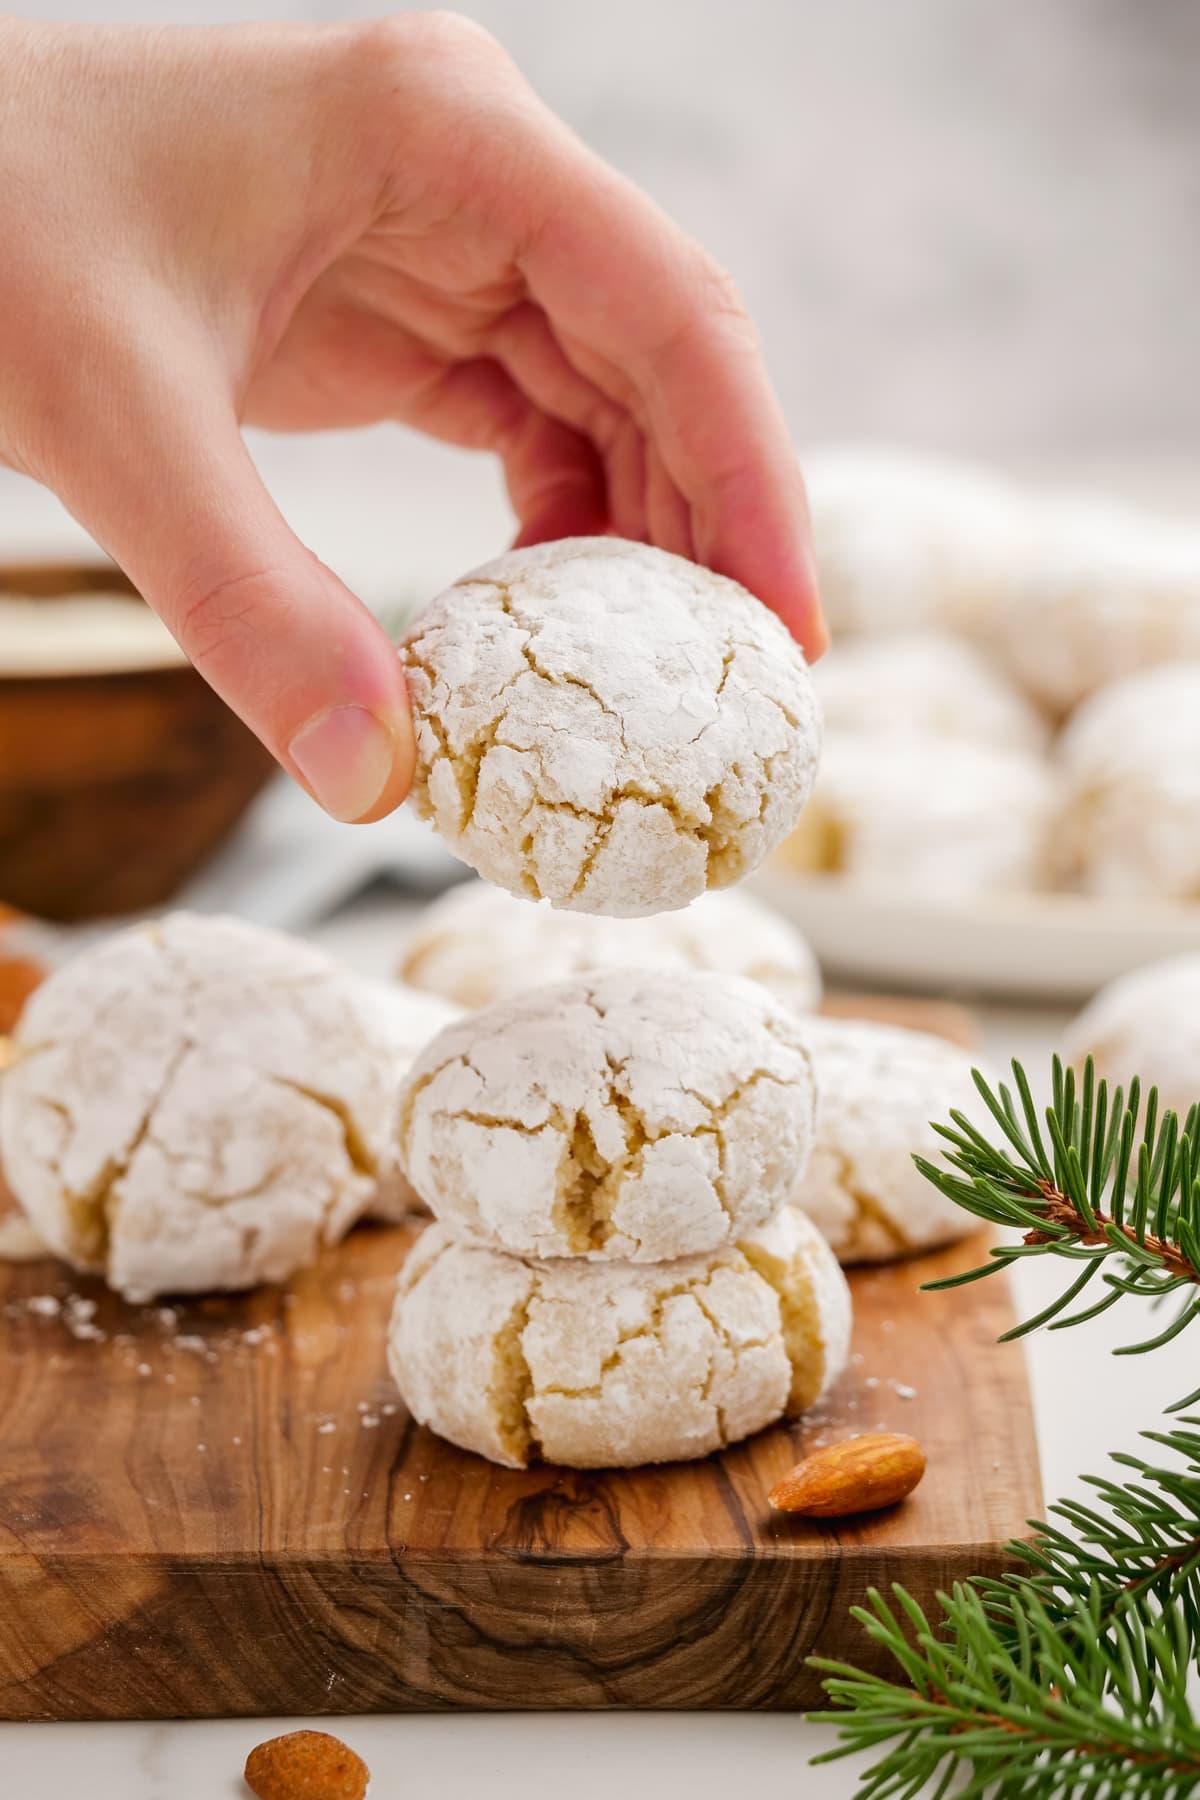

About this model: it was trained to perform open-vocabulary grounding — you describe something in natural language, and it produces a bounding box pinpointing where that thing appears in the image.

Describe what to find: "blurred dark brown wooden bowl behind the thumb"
[0,563,273,920]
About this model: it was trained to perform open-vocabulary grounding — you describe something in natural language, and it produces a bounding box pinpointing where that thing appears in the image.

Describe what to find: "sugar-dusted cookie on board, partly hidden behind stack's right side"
[792,1019,977,1264]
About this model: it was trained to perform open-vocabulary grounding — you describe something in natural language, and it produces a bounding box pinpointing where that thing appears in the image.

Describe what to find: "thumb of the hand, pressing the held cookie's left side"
[41,331,414,821]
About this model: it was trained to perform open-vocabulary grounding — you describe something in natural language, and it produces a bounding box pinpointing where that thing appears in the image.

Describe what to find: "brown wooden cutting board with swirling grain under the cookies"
[0,1003,1042,1719]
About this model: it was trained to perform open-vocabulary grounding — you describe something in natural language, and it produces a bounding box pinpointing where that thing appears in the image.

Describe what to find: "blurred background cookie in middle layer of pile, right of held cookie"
[813,632,1047,751]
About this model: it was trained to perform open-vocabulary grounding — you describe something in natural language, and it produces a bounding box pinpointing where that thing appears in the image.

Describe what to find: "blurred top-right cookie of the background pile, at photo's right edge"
[982,495,1200,713]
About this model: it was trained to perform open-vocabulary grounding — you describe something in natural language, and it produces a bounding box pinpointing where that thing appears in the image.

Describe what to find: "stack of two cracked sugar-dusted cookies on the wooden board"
[389,968,851,1467]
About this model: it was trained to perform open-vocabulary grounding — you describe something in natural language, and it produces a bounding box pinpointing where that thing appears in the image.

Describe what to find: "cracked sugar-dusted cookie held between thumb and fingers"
[399,538,820,918]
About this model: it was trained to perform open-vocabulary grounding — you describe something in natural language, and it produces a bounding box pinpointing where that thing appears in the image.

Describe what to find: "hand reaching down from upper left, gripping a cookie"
[0,13,822,819]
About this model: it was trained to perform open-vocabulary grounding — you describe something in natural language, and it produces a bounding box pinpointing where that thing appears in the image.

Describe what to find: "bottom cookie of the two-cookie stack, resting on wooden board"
[389,1211,851,1469]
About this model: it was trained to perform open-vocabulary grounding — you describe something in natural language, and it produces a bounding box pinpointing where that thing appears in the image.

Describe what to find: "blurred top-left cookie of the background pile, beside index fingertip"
[802,445,1031,635]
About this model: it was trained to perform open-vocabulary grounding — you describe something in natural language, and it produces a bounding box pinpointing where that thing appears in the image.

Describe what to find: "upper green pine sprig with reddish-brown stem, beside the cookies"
[916,1058,1200,1360]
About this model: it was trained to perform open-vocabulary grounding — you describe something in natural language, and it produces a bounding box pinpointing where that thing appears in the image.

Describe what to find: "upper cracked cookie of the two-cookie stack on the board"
[399,970,815,1262]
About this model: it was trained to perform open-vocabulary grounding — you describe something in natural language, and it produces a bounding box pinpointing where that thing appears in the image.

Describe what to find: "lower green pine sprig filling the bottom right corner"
[811,1420,1200,1800]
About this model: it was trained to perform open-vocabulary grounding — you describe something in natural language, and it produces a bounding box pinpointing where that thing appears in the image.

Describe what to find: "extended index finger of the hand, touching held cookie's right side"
[520,146,826,655]
